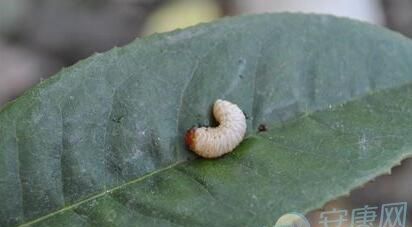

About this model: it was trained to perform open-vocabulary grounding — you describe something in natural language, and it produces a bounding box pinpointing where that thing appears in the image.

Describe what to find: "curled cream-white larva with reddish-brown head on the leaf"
[185,99,246,158]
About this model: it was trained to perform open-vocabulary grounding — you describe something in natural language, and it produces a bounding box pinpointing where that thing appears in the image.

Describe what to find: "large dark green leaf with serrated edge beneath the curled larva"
[0,14,412,226]
